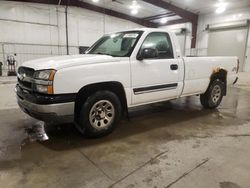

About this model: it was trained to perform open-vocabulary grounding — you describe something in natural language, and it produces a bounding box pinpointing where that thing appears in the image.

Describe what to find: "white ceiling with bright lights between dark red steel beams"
[80,0,250,24]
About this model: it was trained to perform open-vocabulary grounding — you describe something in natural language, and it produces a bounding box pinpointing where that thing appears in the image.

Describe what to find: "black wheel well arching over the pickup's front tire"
[74,82,128,121]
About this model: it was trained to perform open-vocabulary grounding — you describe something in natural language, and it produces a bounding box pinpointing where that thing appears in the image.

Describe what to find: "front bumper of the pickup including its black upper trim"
[16,85,75,122]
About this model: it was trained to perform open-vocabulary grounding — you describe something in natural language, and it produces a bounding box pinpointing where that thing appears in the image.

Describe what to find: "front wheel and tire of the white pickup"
[76,91,122,138]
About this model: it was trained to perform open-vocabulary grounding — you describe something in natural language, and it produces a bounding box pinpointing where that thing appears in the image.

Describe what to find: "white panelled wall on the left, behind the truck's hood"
[0,1,142,75]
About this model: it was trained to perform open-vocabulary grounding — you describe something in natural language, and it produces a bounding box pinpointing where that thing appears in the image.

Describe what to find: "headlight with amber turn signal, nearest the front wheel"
[34,70,56,94]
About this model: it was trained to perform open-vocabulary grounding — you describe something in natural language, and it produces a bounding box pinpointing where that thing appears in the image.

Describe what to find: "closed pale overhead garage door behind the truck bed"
[208,28,248,71]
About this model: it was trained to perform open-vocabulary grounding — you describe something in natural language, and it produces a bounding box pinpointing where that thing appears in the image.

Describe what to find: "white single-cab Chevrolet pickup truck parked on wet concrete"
[16,28,239,137]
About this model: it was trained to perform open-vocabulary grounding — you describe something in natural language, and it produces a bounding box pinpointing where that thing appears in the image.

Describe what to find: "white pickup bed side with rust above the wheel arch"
[182,56,238,96]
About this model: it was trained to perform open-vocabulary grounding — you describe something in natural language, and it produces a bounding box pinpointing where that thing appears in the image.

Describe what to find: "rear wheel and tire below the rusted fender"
[200,79,225,109]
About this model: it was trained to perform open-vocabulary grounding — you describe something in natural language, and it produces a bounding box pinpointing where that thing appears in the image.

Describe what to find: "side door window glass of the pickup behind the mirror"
[139,32,174,59]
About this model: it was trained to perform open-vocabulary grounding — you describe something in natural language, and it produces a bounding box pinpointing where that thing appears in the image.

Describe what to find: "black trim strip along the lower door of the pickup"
[133,83,178,95]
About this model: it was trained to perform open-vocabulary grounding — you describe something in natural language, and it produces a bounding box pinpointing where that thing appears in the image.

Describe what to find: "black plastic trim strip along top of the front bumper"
[16,84,76,105]
